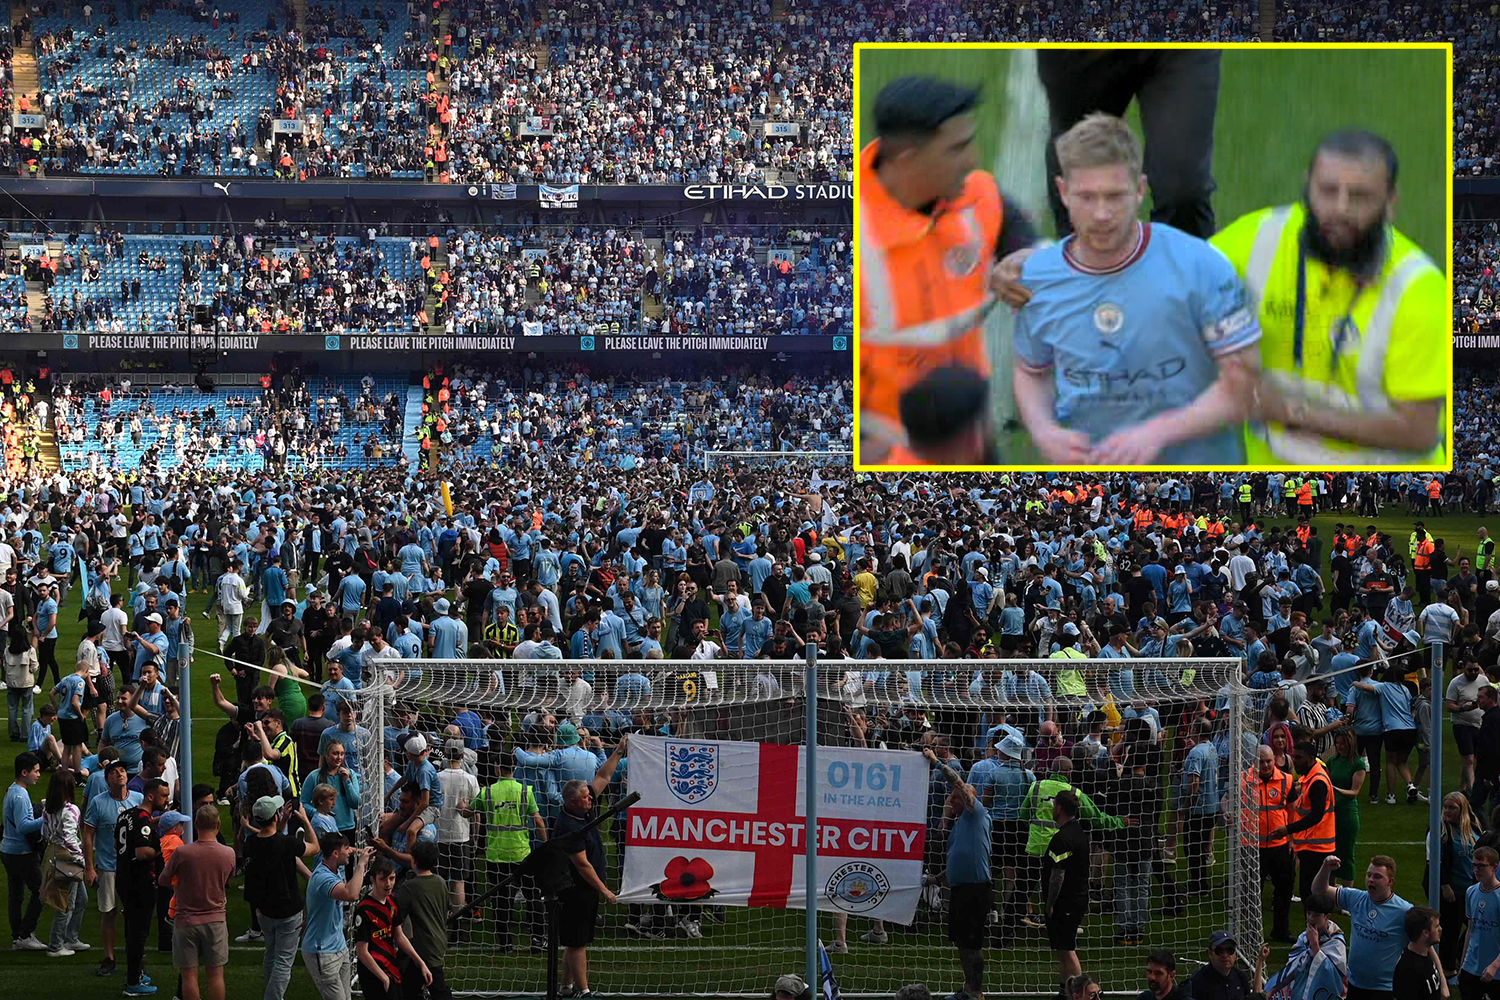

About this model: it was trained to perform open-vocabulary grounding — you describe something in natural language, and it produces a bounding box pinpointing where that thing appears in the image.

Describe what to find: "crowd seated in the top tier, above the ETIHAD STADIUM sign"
[5,0,1500,184]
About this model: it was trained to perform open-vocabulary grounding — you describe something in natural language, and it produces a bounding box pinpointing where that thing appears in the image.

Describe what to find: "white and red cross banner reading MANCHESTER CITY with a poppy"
[620,736,930,924]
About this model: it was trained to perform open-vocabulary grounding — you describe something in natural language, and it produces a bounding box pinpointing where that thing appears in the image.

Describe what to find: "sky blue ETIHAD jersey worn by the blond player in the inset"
[1016,223,1260,465]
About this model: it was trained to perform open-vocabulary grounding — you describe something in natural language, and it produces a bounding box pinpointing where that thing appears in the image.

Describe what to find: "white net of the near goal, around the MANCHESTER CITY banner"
[368,658,1268,997]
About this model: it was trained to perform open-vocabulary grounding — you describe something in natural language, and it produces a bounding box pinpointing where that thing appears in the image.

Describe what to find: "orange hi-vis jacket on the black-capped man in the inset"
[858,139,1005,451]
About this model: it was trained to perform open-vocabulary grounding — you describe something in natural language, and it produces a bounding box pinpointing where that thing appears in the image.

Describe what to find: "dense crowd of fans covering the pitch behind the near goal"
[0,425,1500,997]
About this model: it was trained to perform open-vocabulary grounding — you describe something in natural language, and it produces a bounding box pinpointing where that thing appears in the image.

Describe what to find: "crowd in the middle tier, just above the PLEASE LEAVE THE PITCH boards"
[17,225,854,337]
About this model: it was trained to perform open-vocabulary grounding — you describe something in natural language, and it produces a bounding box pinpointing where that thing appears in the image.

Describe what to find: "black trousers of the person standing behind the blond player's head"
[1037,49,1220,240]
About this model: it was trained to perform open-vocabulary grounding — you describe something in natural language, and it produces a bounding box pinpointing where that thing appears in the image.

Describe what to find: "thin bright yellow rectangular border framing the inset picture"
[852,42,1455,474]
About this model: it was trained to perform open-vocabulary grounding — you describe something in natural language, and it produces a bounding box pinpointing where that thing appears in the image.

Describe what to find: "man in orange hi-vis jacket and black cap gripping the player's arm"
[855,76,1035,463]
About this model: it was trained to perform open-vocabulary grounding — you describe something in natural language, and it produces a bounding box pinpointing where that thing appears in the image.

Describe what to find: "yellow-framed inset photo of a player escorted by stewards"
[854,43,1454,471]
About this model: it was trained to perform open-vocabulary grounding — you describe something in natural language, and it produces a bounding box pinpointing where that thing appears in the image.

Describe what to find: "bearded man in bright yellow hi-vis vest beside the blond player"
[1212,132,1452,468]
